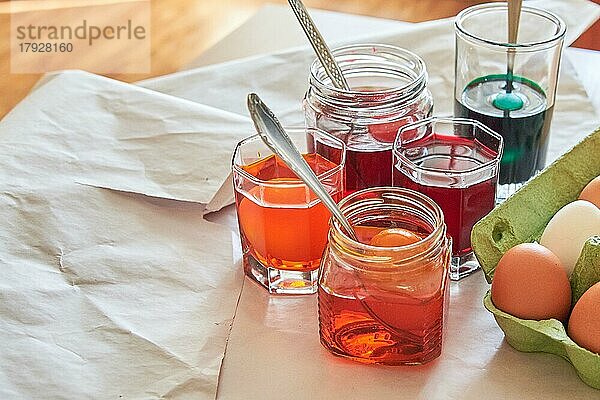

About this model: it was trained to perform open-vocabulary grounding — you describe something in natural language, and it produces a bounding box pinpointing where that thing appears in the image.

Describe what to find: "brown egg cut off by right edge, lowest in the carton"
[568,282,600,354]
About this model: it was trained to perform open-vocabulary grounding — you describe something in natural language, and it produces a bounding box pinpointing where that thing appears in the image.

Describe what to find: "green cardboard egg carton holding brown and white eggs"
[471,129,600,389]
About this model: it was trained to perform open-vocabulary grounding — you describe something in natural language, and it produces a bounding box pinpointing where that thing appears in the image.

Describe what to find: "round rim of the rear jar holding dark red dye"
[310,43,428,97]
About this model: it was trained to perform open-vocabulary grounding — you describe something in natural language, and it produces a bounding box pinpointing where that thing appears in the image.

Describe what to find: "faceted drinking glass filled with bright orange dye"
[232,128,346,294]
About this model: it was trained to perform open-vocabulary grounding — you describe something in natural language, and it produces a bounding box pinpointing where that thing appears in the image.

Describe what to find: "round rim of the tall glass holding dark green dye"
[454,3,567,51]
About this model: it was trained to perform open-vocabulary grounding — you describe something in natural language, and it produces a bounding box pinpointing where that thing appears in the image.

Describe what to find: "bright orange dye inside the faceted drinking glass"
[236,154,341,273]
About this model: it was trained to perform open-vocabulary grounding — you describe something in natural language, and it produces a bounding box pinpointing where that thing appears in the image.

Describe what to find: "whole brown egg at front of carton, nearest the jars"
[492,243,571,321]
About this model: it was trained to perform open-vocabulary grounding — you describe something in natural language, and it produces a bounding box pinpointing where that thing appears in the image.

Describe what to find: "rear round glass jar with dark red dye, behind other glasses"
[304,44,433,192]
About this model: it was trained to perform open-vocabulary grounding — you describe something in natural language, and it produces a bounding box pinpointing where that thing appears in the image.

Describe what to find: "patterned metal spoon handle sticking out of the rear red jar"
[288,0,350,90]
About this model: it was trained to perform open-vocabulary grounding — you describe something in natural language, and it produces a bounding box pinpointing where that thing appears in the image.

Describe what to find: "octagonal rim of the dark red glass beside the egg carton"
[392,117,504,176]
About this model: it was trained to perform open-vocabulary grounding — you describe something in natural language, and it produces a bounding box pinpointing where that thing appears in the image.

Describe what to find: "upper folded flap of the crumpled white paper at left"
[0,71,253,209]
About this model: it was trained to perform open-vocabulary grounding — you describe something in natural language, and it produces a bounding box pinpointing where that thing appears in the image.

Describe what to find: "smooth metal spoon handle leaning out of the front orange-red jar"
[248,93,358,241]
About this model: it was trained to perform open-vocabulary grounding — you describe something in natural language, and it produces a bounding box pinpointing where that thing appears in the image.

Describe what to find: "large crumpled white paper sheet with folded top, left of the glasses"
[0,72,249,399]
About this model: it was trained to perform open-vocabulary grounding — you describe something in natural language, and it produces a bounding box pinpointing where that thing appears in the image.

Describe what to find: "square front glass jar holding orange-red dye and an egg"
[318,187,451,365]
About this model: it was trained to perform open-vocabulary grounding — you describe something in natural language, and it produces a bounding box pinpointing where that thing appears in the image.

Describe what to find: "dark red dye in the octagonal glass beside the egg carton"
[394,134,497,257]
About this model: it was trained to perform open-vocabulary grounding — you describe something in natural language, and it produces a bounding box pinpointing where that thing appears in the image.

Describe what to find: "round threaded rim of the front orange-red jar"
[330,186,446,255]
